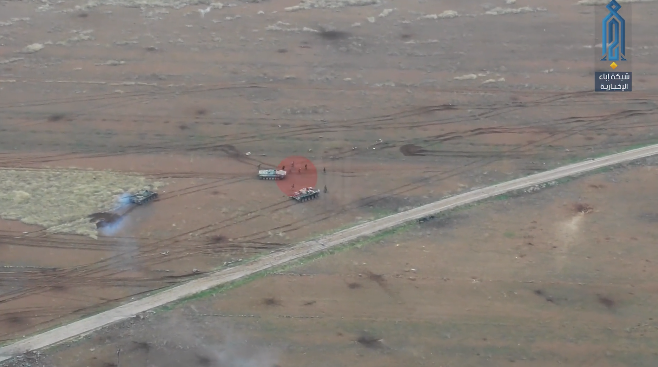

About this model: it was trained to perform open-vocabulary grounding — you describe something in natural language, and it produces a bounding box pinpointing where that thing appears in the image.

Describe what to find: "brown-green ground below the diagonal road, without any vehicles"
[11,159,658,367]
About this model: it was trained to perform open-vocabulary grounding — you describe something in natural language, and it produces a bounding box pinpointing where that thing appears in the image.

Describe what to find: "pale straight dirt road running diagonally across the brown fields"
[0,145,658,362]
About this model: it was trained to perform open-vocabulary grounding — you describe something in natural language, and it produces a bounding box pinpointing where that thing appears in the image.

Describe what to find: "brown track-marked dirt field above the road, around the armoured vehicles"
[0,1,658,348]
